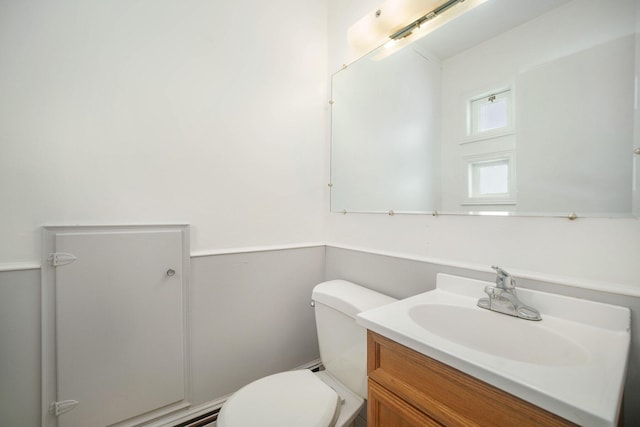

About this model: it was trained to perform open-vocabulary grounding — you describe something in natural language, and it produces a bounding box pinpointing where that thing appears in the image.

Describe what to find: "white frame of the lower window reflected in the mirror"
[462,150,516,205]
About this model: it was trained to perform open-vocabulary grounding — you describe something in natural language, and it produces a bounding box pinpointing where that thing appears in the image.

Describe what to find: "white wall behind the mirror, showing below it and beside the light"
[325,0,640,292]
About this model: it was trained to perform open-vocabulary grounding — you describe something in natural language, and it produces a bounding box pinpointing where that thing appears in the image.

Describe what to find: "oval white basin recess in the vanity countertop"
[408,304,588,366]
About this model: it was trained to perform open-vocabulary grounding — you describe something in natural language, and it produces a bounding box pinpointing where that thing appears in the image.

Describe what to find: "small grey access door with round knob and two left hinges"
[55,230,185,427]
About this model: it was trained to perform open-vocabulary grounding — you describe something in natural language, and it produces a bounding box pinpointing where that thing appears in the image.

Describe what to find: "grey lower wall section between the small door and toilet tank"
[190,246,325,405]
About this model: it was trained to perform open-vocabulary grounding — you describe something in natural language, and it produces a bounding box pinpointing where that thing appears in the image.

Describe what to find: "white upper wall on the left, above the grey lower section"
[0,0,326,264]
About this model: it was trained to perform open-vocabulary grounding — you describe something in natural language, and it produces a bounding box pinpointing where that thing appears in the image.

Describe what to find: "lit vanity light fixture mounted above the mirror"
[348,0,487,59]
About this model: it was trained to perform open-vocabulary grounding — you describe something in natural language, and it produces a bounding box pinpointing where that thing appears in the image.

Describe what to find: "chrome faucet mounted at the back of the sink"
[478,265,542,320]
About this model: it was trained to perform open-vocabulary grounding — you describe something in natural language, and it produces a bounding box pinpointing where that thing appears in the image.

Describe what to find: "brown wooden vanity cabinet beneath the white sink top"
[367,331,576,427]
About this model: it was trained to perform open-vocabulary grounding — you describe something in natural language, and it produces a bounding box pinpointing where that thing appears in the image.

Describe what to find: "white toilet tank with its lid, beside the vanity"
[312,280,396,399]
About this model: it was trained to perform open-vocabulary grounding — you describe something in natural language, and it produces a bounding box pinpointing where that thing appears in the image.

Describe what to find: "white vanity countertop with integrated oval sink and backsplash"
[358,274,631,427]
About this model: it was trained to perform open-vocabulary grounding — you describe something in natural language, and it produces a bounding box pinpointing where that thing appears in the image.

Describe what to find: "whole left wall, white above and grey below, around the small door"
[0,0,328,426]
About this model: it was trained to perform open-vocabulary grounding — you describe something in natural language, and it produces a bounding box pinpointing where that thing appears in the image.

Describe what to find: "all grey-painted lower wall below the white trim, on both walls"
[0,245,640,427]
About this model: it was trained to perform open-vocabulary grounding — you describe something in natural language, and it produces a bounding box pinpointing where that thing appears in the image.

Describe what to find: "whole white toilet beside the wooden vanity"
[217,280,396,427]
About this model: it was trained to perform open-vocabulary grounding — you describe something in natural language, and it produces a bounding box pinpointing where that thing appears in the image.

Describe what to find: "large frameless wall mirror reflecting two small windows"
[331,0,640,216]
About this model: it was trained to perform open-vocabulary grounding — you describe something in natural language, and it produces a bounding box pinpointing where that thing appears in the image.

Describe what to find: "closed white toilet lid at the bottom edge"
[217,369,340,427]
